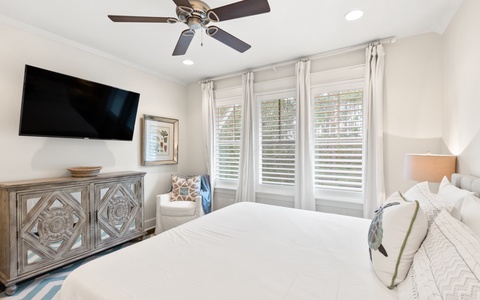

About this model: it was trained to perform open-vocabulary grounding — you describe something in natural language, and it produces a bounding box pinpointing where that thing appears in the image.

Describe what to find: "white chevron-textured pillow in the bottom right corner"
[397,211,480,300]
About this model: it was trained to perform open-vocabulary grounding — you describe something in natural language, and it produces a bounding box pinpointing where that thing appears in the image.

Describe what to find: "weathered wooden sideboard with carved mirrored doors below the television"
[0,172,145,295]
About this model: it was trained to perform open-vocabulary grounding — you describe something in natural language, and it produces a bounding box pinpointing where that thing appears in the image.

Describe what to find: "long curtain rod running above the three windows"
[198,37,396,83]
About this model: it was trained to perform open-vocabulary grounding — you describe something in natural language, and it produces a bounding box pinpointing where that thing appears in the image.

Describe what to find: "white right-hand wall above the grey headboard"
[442,0,480,176]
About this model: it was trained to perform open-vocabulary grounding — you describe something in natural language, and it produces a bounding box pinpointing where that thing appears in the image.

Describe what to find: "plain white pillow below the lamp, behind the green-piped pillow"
[404,181,454,227]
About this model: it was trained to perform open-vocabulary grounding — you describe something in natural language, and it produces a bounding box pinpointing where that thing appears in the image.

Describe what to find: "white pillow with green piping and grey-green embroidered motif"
[368,192,427,288]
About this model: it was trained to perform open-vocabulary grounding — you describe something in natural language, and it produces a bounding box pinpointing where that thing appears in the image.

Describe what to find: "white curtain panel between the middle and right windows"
[295,60,315,210]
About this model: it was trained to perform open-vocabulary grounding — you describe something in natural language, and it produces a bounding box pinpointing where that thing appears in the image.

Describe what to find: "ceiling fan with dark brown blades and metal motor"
[108,0,270,56]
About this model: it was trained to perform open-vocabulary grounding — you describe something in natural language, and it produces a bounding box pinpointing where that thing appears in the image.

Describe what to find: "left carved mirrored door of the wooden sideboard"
[18,186,91,274]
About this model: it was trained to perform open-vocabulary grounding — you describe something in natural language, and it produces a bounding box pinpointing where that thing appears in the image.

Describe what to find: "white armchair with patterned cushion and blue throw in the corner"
[155,175,210,234]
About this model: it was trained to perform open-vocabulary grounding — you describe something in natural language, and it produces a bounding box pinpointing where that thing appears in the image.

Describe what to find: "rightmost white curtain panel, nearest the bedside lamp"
[363,44,385,218]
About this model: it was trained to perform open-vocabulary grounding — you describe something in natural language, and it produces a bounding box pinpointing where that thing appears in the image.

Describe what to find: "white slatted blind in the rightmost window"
[314,89,363,191]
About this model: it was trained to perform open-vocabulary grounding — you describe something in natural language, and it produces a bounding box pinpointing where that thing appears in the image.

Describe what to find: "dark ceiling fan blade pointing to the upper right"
[207,0,270,22]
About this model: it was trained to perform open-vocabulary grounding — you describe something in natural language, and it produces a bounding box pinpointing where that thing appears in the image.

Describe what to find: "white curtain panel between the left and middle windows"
[235,72,255,202]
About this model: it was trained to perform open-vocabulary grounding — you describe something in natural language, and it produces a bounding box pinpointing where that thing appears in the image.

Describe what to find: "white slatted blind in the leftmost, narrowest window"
[215,104,242,180]
